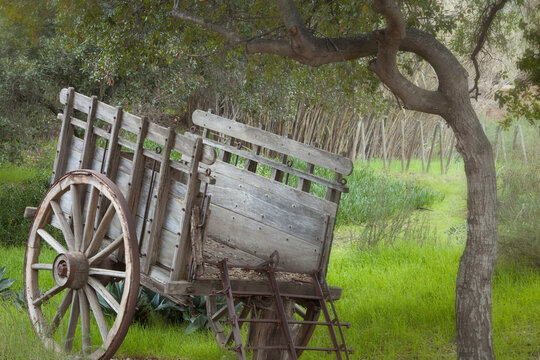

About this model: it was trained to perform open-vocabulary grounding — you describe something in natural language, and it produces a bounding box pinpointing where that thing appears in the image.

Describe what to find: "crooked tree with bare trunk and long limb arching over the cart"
[171,0,506,359]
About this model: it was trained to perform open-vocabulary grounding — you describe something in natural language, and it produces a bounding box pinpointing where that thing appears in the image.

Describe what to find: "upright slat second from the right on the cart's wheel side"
[142,128,175,274]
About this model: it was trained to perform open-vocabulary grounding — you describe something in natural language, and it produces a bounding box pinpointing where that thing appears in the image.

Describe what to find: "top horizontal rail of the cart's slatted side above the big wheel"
[60,89,216,164]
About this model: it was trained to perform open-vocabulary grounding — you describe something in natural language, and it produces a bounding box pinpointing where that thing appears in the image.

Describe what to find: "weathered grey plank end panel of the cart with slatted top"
[192,110,352,272]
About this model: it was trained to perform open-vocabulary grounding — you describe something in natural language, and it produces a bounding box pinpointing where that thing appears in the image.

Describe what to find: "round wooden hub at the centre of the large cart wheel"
[52,252,89,289]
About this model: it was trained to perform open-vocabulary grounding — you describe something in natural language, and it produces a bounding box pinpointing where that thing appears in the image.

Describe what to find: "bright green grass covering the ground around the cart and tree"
[0,161,540,360]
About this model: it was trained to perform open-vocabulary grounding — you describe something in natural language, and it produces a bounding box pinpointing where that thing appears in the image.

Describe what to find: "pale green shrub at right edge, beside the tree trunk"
[499,164,540,269]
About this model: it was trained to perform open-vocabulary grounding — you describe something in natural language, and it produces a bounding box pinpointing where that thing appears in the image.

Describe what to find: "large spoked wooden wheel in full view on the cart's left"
[24,170,139,359]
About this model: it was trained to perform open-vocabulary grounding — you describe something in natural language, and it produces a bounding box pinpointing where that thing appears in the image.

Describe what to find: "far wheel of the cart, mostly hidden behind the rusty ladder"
[206,295,321,356]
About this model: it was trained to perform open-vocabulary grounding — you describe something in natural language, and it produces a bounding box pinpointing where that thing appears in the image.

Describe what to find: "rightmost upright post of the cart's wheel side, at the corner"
[170,137,203,281]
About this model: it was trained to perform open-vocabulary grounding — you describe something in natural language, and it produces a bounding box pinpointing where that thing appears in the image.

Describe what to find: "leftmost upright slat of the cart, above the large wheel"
[51,87,75,183]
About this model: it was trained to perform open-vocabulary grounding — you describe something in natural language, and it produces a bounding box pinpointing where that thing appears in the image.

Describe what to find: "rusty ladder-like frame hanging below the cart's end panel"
[215,251,354,360]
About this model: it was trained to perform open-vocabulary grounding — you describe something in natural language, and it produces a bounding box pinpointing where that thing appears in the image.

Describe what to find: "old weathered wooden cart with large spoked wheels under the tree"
[24,88,352,359]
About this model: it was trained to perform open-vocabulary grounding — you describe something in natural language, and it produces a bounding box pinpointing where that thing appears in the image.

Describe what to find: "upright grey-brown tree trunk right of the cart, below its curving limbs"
[445,98,497,360]
